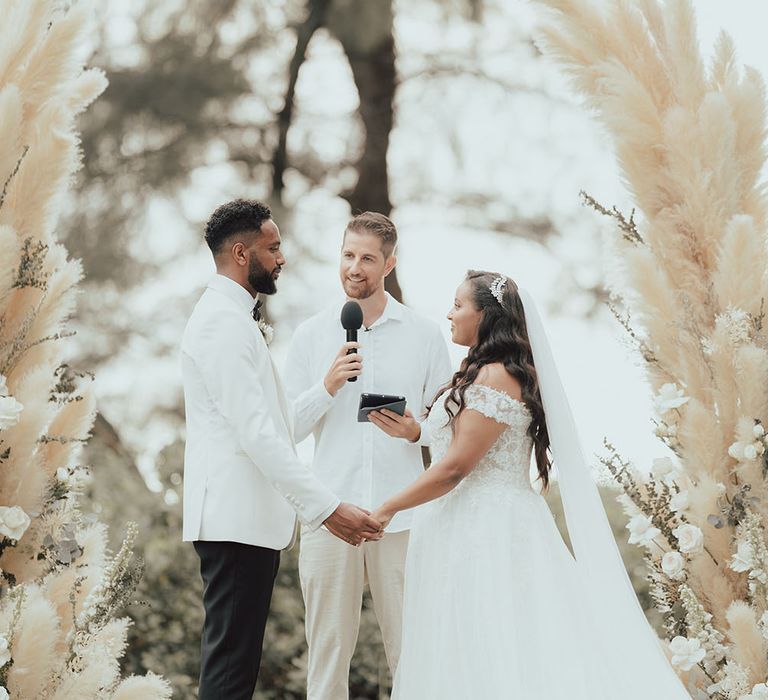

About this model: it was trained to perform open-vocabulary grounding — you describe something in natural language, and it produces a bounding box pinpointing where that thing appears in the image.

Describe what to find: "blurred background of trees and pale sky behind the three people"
[62,0,768,699]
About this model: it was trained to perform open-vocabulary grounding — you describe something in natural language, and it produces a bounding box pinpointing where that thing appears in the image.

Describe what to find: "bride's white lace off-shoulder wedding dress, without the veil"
[392,385,664,700]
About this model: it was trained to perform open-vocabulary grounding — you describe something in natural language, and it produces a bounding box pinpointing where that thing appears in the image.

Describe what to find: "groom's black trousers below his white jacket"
[194,541,280,700]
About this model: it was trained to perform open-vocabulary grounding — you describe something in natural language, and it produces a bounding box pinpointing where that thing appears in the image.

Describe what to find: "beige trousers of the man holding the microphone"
[299,528,408,700]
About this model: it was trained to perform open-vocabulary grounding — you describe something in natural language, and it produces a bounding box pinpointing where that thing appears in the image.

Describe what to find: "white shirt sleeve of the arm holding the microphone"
[283,326,334,442]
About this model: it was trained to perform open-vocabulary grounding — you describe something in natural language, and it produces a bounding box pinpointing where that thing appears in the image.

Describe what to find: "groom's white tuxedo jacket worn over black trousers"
[181,275,339,549]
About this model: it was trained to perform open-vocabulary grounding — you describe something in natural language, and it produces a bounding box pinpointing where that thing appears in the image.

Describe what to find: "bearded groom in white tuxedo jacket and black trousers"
[181,200,381,700]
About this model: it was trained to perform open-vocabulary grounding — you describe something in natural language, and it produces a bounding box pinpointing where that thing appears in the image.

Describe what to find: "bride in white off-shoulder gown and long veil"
[373,271,690,700]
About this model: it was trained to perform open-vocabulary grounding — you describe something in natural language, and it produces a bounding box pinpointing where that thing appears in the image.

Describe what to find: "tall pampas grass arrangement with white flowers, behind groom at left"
[0,0,170,700]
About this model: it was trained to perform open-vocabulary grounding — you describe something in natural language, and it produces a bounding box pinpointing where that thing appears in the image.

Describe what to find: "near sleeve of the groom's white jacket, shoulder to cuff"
[198,315,340,528]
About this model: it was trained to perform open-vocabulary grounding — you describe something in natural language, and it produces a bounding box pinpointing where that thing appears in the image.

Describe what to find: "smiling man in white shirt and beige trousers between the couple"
[285,212,451,700]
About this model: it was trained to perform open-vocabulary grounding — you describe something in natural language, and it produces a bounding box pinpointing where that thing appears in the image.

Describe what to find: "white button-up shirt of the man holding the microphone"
[283,295,451,532]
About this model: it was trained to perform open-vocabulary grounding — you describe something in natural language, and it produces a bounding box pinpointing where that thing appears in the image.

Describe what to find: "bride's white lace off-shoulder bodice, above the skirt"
[428,384,533,500]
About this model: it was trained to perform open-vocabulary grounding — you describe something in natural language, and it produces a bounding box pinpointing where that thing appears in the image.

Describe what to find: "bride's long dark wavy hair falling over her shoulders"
[430,270,552,490]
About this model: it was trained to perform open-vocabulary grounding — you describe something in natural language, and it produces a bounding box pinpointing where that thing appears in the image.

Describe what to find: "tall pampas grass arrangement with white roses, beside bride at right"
[538,0,768,700]
